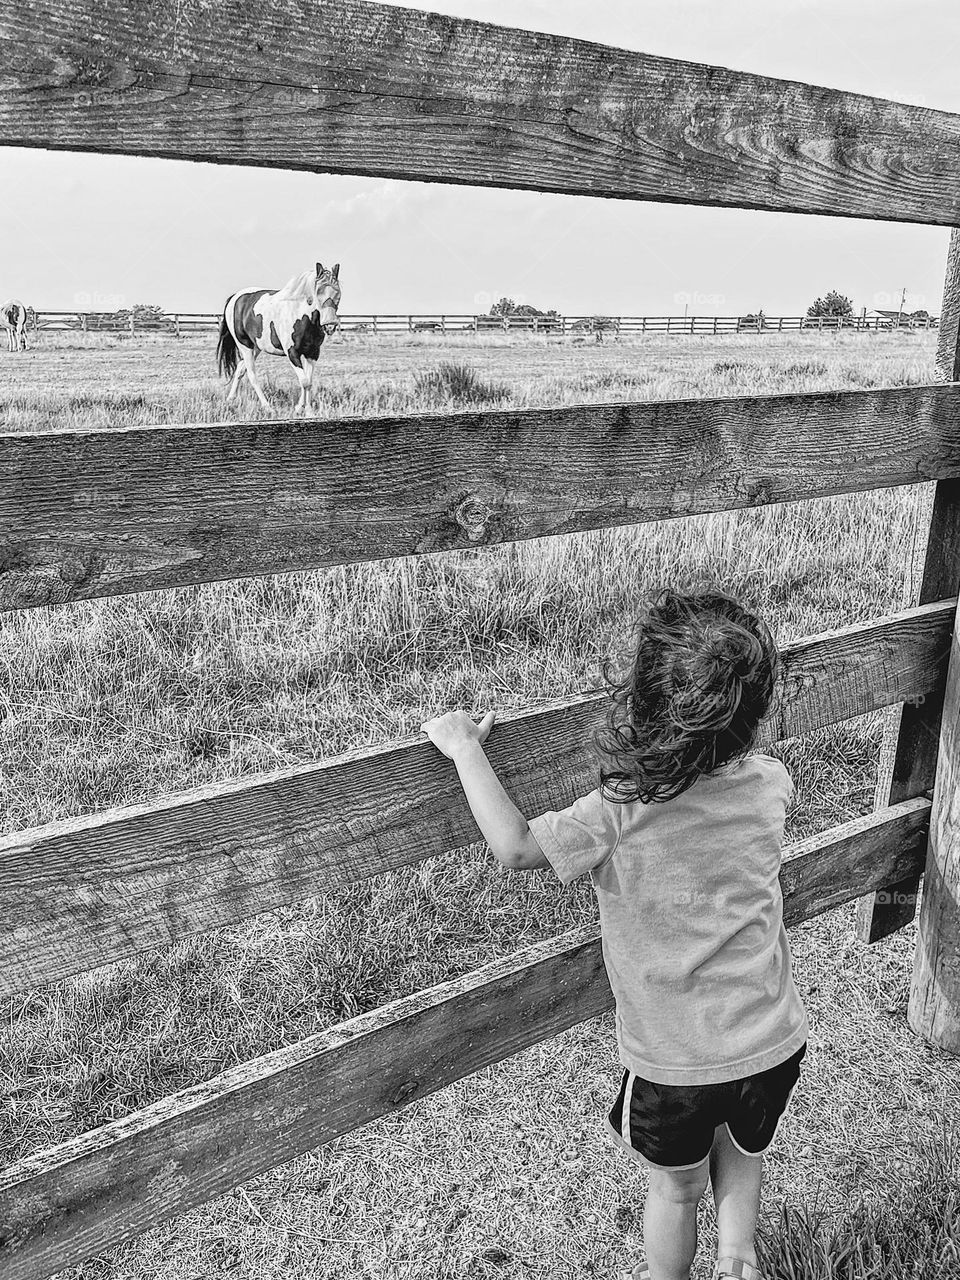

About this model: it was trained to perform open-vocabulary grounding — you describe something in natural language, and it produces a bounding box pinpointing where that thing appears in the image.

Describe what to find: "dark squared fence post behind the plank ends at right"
[858,229,960,942]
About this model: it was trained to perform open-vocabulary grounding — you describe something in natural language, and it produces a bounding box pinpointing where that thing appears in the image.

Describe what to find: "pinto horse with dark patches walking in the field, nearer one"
[216,262,340,413]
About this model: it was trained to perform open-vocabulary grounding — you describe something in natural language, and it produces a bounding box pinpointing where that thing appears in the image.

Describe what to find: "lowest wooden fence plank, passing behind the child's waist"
[0,800,931,1280]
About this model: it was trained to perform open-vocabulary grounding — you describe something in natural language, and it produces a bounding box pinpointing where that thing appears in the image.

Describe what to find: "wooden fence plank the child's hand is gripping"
[0,602,952,995]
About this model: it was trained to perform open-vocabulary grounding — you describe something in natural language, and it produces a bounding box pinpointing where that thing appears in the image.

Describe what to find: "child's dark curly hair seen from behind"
[594,588,780,804]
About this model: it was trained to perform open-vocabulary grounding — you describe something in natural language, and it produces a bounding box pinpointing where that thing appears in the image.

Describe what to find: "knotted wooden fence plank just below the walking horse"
[0,387,960,608]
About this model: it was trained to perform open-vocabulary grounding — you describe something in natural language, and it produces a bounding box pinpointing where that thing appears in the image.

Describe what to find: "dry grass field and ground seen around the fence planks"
[0,334,960,1280]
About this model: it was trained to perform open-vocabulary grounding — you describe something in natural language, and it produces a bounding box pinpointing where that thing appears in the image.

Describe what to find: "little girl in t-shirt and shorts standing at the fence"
[422,590,806,1280]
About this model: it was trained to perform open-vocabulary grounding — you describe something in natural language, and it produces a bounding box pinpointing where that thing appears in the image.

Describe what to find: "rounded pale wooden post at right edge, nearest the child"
[906,599,960,1055]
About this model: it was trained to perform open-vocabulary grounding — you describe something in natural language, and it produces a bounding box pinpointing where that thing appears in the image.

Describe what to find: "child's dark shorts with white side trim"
[605,1044,806,1170]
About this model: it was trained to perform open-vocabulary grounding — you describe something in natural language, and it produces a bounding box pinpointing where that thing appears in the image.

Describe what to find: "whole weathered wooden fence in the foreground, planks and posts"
[0,0,960,1280]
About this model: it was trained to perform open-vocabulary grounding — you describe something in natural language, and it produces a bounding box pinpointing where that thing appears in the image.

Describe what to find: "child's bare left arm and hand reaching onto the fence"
[420,710,548,870]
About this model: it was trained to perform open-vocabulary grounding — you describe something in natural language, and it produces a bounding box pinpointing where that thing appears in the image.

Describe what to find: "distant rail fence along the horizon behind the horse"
[29,311,938,338]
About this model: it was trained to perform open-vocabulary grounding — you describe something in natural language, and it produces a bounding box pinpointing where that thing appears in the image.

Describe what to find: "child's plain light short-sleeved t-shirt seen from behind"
[530,754,808,1084]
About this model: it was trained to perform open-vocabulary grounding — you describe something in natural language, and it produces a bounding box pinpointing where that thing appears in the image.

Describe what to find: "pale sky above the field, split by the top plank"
[0,0,960,315]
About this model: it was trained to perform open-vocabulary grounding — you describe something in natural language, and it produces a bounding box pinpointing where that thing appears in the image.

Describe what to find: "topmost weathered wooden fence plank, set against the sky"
[0,0,960,225]
